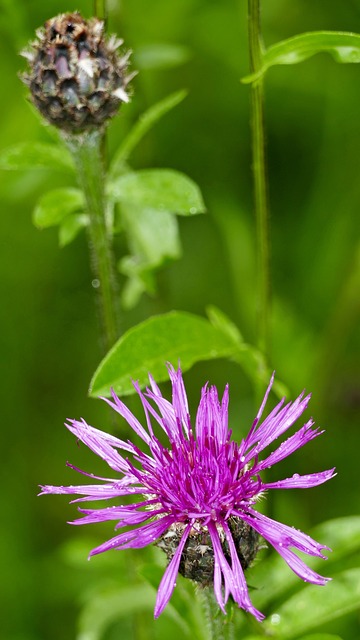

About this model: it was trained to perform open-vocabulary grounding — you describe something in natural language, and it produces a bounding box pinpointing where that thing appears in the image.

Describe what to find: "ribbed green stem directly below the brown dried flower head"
[66,130,119,351]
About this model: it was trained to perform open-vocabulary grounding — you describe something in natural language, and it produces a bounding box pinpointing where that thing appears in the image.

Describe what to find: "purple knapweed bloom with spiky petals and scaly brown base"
[41,365,334,620]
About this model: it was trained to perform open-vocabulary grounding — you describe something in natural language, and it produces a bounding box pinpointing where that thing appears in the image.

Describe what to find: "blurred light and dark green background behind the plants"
[0,0,360,640]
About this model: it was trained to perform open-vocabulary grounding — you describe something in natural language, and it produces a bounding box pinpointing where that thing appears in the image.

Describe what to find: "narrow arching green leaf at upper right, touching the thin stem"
[242,31,360,84]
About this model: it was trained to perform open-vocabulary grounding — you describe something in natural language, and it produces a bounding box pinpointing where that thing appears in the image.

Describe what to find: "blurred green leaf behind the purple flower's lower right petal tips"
[247,516,360,609]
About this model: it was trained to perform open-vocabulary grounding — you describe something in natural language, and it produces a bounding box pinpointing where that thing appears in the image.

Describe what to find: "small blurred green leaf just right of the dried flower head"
[134,42,191,69]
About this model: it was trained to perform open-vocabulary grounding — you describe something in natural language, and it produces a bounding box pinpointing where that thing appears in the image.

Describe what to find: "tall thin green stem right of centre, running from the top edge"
[248,0,270,361]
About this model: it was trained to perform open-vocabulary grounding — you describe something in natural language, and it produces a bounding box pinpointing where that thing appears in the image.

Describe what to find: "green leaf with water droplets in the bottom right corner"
[263,568,360,640]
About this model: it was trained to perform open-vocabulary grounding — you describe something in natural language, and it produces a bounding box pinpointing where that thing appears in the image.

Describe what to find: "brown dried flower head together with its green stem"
[22,10,134,350]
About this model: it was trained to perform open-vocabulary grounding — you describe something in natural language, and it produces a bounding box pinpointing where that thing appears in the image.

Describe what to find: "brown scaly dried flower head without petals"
[22,12,134,132]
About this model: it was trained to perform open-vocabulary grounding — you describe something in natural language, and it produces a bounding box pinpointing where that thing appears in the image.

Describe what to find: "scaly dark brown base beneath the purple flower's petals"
[156,517,260,587]
